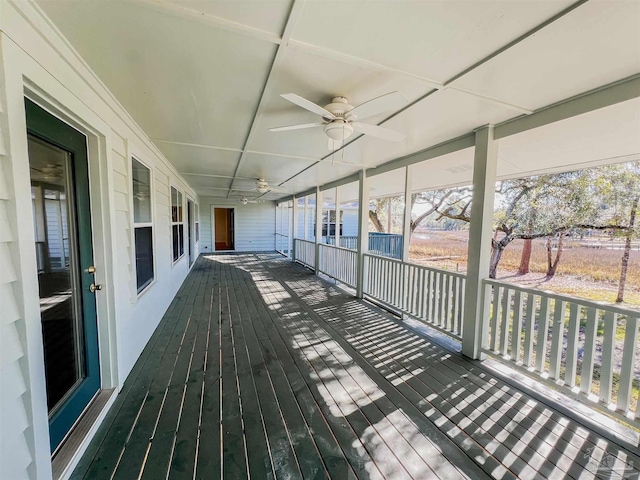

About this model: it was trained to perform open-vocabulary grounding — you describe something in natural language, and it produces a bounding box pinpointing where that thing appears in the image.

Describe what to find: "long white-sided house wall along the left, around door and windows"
[0,1,198,480]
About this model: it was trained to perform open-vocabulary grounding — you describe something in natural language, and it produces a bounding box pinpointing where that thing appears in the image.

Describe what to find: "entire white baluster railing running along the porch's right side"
[294,235,640,422]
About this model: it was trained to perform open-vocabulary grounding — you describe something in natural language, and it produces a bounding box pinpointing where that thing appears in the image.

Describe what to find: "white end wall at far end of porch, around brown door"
[200,197,276,253]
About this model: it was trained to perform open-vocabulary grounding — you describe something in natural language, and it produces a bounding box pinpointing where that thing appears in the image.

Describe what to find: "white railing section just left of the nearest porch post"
[364,254,465,338]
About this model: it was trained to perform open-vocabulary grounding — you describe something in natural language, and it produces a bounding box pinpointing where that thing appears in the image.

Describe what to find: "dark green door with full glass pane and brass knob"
[25,100,100,452]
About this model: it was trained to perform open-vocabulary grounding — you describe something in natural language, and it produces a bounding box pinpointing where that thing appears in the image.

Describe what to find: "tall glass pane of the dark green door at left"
[29,136,86,416]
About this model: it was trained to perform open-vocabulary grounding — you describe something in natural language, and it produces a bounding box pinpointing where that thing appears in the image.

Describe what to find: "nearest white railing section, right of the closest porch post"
[483,280,640,421]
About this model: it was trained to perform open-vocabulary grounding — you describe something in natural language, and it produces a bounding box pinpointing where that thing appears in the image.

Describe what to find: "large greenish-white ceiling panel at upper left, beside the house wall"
[35,0,276,148]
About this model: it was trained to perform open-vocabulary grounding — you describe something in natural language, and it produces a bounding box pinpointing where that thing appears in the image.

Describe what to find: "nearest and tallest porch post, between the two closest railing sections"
[462,125,498,359]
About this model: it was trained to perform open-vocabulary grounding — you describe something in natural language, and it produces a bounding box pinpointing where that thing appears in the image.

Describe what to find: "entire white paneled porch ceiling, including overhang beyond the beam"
[39,0,640,198]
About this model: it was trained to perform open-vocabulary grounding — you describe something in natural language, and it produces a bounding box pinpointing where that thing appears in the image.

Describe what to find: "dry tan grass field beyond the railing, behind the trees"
[410,230,640,307]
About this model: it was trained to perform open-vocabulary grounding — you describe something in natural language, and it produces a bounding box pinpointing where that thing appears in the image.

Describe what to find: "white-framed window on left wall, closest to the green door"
[131,158,153,293]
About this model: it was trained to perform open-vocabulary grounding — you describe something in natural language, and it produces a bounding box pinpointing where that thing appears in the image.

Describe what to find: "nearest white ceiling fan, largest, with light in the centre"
[269,92,408,150]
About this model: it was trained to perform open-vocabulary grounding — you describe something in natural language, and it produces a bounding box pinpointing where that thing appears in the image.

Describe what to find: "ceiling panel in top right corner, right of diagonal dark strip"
[454,1,640,109]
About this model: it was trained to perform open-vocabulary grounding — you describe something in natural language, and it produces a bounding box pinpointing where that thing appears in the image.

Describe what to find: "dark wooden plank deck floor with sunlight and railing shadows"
[72,254,640,479]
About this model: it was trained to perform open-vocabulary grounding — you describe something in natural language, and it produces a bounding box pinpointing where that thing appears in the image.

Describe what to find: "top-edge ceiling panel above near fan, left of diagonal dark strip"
[293,0,572,82]
